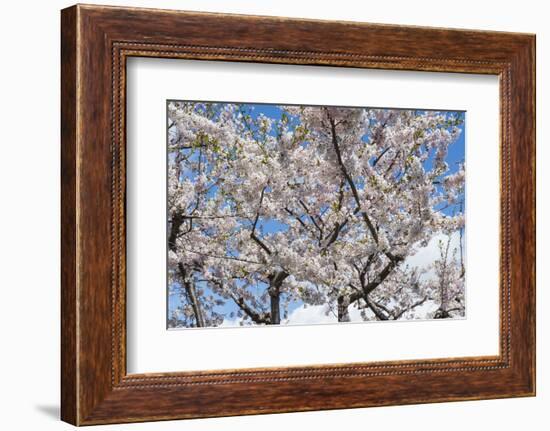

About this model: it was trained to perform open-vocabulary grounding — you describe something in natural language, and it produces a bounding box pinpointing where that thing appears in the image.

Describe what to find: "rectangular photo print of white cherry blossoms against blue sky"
[167,100,466,329]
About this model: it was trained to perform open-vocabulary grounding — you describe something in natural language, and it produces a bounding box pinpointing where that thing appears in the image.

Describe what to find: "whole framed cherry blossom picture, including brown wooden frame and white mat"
[61,5,535,425]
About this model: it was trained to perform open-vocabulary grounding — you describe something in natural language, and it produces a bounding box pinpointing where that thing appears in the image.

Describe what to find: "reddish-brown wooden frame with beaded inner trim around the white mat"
[61,5,535,425]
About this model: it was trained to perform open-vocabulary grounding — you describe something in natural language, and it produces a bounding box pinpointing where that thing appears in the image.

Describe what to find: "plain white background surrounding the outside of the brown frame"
[0,0,550,431]
